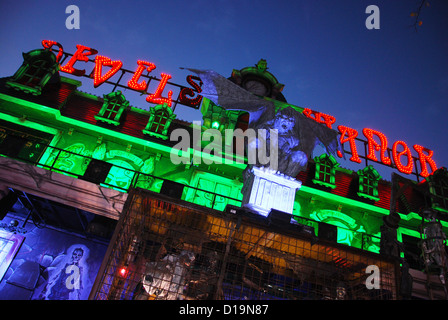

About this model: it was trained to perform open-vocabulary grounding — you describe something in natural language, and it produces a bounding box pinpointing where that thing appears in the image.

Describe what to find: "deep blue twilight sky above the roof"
[0,0,448,179]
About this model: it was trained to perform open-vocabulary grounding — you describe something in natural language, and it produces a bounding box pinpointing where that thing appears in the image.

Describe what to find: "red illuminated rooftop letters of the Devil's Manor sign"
[42,40,437,177]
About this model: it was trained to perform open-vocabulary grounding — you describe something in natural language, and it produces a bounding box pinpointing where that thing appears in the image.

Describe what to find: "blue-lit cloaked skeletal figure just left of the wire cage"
[39,244,89,300]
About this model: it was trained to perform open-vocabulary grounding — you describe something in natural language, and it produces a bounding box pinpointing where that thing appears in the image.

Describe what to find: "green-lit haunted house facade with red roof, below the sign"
[0,46,448,300]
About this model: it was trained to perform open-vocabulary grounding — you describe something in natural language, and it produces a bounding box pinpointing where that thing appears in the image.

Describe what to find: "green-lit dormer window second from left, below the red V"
[95,91,129,126]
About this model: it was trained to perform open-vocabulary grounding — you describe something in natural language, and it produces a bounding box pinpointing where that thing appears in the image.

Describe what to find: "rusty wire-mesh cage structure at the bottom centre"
[90,189,398,300]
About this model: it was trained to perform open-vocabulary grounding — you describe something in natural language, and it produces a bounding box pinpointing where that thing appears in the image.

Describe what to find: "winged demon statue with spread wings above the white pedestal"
[182,68,344,177]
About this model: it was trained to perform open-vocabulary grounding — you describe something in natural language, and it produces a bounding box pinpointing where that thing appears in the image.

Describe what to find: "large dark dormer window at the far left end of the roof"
[6,49,59,96]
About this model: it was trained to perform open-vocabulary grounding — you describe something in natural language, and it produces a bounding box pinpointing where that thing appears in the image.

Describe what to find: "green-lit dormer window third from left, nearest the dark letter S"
[143,104,176,140]
